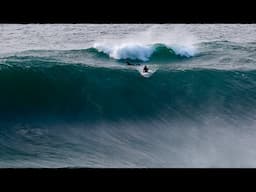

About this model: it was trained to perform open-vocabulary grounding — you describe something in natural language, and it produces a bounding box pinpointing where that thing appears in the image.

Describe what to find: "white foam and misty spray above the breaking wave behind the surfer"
[93,25,197,61]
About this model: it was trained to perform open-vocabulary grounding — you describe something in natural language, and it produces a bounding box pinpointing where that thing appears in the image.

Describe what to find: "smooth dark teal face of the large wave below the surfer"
[0,64,256,121]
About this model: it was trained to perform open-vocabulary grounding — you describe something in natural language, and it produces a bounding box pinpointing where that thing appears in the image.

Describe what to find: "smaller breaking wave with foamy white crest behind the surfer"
[93,43,196,62]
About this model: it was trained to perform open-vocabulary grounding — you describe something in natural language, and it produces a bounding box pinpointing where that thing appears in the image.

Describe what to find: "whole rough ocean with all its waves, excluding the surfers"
[0,24,256,168]
